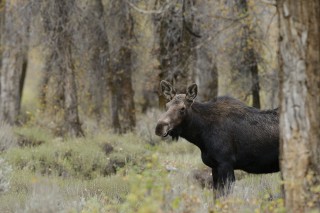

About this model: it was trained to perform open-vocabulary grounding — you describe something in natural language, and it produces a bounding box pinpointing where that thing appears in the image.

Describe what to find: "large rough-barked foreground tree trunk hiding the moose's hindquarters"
[278,0,320,212]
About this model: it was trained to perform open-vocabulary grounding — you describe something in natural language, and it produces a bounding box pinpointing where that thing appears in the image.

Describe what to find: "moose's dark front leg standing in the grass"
[212,163,235,197]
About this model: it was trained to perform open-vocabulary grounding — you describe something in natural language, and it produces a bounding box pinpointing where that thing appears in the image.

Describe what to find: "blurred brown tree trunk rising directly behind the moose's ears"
[159,0,194,106]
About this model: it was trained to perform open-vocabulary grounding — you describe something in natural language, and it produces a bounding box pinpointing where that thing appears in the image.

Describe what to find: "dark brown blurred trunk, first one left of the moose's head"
[108,0,136,133]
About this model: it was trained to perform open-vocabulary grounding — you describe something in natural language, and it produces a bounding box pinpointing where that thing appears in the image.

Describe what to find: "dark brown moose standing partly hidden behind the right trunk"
[155,80,279,192]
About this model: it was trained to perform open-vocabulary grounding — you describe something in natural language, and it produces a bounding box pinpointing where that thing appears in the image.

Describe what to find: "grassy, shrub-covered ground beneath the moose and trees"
[0,111,284,213]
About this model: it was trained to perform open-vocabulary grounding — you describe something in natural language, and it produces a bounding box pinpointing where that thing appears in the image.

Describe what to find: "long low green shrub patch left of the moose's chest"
[6,131,149,179]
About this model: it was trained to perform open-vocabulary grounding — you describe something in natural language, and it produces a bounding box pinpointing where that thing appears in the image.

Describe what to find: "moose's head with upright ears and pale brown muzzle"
[156,81,198,139]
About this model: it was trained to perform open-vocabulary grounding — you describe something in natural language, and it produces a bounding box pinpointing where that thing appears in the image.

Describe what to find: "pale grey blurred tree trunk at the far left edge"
[0,1,29,125]
